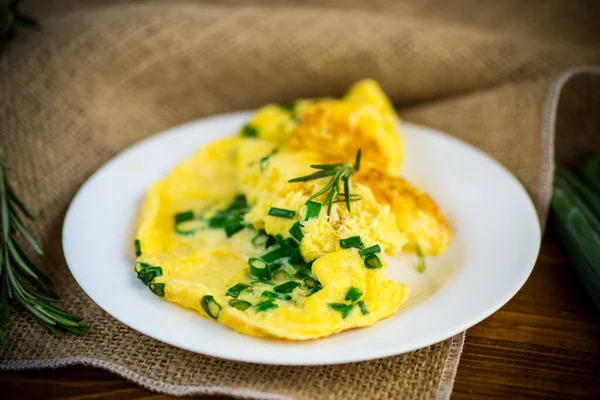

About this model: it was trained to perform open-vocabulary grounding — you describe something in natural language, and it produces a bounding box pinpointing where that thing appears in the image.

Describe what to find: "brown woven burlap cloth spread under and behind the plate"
[0,0,600,399]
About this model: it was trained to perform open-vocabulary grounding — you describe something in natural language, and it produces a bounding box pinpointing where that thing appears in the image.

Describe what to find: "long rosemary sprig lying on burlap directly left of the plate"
[0,157,89,346]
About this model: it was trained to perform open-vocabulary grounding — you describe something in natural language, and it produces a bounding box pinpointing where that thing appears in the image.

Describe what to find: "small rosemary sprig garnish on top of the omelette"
[288,149,362,215]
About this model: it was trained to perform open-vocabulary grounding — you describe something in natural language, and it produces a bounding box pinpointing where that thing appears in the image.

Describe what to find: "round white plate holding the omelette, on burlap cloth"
[63,113,541,365]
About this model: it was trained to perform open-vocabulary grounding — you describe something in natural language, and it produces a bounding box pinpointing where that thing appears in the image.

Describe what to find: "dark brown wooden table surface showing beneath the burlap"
[0,229,600,400]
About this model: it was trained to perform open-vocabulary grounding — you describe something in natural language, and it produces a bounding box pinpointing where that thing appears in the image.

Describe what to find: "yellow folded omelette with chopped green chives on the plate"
[135,80,452,340]
